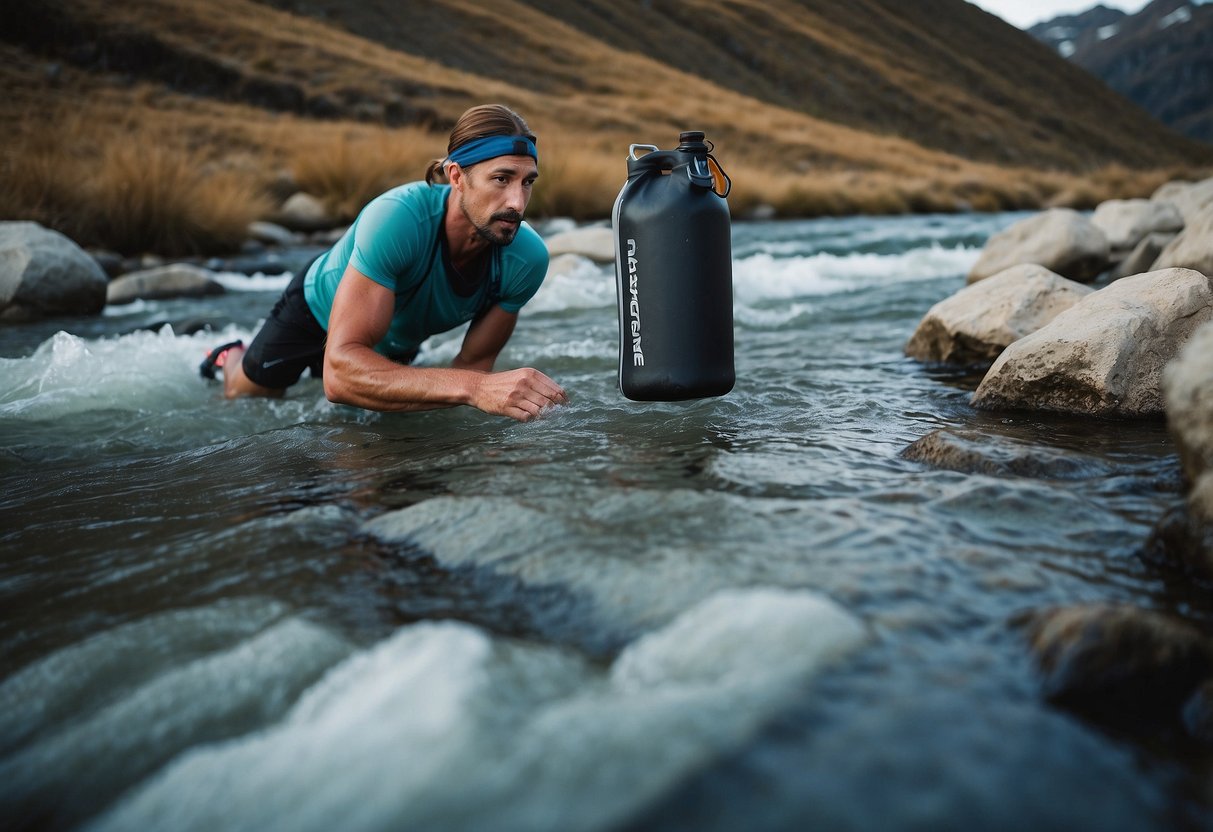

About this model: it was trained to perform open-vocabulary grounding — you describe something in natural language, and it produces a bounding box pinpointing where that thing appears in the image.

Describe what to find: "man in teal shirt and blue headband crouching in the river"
[201,104,568,421]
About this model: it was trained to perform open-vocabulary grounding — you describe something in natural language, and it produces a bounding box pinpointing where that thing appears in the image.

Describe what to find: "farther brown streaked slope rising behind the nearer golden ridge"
[253,0,1194,170]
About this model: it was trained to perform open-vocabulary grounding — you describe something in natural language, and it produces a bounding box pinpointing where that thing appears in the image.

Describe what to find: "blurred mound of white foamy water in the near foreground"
[92,588,867,830]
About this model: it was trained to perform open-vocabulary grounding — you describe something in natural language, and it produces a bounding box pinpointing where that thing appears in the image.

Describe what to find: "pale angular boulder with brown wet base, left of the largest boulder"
[905,264,1093,366]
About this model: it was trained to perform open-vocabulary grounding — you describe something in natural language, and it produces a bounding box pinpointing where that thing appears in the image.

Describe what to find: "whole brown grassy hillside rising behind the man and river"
[0,0,1213,254]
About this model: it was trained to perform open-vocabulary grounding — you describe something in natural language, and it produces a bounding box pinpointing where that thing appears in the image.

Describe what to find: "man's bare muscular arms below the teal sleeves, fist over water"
[324,266,568,422]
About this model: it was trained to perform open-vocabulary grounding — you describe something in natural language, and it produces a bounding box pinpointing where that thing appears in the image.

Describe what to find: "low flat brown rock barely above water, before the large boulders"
[901,428,1106,479]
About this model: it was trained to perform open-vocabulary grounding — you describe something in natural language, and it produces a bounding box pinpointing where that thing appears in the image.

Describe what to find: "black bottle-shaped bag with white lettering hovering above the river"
[611,132,735,401]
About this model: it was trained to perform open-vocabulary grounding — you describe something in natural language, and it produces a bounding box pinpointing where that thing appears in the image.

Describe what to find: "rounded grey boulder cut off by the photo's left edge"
[0,222,108,321]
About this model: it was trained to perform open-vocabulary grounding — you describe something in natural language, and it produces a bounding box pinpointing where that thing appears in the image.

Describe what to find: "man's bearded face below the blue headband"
[459,156,539,245]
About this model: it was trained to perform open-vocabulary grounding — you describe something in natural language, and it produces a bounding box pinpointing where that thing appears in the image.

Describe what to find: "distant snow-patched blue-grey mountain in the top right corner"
[1029,0,1213,143]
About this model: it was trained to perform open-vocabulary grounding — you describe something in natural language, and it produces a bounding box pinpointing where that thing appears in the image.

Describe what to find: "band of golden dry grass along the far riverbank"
[0,89,1209,256]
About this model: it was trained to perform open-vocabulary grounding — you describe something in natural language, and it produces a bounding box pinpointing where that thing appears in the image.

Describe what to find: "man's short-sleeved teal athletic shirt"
[303,182,547,360]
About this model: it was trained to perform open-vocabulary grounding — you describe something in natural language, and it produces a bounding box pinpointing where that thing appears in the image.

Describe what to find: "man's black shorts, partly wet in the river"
[241,263,329,389]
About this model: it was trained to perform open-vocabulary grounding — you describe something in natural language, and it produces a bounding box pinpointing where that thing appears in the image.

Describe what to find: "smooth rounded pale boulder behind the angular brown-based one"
[968,209,1110,283]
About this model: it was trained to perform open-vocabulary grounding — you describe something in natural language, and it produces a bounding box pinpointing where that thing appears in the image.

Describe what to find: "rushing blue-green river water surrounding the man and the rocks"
[0,215,1213,831]
